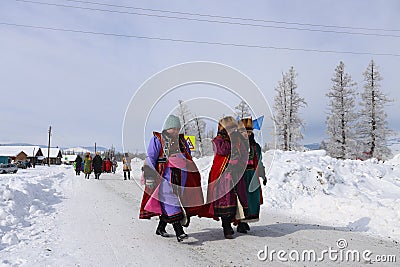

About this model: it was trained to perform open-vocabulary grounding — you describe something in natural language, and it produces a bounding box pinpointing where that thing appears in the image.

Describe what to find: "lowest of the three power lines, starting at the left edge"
[0,22,400,57]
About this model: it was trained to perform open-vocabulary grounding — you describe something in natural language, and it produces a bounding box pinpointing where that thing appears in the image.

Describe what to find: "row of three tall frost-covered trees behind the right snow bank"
[273,60,393,159]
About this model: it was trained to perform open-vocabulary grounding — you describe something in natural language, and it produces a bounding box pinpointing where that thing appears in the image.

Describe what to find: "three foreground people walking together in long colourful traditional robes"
[139,115,267,242]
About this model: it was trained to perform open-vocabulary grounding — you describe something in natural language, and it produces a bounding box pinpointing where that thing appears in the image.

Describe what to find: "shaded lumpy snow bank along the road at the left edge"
[0,166,64,250]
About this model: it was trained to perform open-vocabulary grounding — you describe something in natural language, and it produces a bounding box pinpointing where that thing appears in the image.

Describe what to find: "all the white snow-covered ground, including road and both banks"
[0,151,400,266]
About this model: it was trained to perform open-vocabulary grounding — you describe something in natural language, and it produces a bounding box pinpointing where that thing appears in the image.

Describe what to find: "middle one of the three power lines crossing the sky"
[15,0,400,38]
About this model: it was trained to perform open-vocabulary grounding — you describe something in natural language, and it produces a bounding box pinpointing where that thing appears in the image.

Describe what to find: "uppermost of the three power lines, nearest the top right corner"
[64,0,400,32]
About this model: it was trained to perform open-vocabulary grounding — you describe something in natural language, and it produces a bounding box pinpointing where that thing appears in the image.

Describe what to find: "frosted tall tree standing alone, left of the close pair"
[274,67,307,150]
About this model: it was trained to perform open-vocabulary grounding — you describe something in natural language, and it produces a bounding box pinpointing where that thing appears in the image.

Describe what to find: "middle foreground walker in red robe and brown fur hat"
[207,117,249,239]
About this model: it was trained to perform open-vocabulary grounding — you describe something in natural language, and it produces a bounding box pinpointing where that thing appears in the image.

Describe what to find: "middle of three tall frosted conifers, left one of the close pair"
[326,61,357,159]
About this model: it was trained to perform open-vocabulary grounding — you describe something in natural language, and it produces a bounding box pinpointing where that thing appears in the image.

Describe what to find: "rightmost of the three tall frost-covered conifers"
[357,60,392,159]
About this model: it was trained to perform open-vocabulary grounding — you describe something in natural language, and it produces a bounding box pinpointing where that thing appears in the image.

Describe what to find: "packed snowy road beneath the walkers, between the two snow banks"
[46,171,400,266]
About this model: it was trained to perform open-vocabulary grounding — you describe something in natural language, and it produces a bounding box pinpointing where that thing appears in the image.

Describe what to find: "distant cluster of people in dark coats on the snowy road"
[74,152,118,179]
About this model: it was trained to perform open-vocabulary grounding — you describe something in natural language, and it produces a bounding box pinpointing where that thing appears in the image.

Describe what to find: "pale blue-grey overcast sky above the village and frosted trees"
[0,0,400,153]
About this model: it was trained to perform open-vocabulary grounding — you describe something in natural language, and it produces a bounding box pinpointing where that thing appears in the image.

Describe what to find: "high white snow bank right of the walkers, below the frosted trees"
[263,151,400,241]
